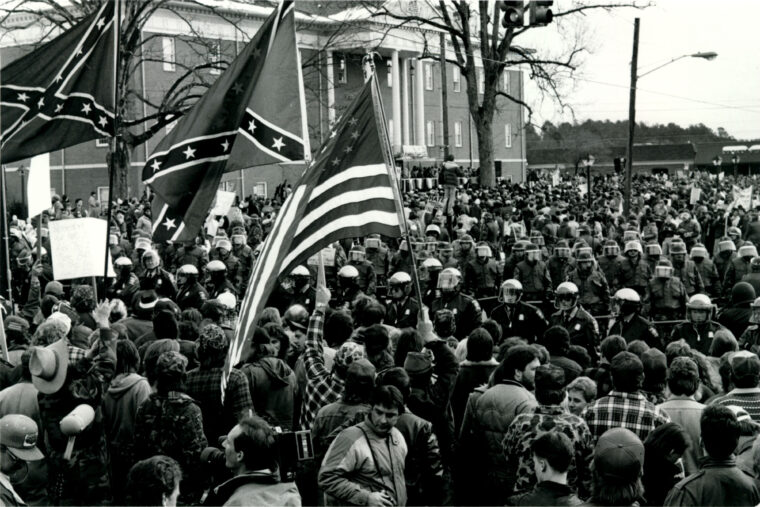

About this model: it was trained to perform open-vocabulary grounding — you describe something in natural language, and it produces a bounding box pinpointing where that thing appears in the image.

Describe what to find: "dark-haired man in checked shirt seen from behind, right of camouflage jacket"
[581,351,670,442]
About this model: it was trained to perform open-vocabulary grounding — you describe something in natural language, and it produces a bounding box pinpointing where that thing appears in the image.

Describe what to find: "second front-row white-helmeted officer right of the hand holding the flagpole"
[490,279,547,343]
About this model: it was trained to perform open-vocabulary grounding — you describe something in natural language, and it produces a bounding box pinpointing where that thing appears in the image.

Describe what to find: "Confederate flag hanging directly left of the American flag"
[142,0,310,242]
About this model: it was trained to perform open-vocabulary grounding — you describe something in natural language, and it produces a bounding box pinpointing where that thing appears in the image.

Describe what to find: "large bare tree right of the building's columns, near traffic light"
[367,0,649,186]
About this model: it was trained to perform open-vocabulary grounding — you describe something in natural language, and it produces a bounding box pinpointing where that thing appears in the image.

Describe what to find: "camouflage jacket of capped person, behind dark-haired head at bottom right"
[502,405,594,498]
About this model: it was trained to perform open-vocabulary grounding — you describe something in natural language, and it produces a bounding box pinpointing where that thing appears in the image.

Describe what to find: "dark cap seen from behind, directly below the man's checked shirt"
[594,428,644,483]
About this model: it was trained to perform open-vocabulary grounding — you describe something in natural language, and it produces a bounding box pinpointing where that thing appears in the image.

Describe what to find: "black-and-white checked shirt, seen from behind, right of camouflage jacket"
[581,390,670,442]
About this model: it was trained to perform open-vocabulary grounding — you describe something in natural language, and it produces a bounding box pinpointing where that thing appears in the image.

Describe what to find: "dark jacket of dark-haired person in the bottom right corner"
[665,456,760,506]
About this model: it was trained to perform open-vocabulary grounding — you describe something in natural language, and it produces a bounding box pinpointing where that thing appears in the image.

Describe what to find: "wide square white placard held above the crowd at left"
[48,218,115,280]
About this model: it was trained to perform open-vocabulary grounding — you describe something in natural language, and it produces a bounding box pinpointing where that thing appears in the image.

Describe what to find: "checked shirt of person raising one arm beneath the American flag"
[300,308,345,430]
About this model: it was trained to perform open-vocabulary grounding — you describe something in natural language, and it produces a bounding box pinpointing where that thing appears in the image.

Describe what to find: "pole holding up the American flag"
[364,53,424,311]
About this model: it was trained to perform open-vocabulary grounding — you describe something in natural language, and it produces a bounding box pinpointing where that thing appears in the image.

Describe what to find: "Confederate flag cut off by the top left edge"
[0,2,119,163]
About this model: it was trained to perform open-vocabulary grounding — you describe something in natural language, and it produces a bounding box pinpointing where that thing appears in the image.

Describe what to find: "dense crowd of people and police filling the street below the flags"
[5,169,760,506]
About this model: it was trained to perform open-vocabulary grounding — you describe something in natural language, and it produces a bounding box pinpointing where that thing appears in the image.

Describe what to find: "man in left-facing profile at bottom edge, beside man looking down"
[204,417,301,506]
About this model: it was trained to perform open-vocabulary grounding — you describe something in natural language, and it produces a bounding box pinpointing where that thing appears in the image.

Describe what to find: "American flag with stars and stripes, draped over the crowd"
[222,73,403,392]
